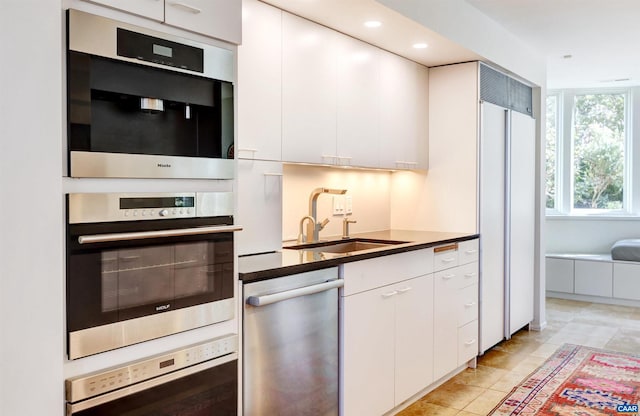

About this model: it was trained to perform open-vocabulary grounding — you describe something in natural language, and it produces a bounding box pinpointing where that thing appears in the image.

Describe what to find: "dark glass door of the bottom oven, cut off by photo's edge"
[68,360,238,416]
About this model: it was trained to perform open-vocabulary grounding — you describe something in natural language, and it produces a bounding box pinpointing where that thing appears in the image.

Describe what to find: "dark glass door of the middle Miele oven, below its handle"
[67,228,233,331]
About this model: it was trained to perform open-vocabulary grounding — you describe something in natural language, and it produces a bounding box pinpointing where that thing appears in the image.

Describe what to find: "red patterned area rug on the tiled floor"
[490,344,640,416]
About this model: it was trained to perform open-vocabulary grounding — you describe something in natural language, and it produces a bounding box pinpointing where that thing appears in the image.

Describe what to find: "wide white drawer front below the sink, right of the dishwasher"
[343,248,433,296]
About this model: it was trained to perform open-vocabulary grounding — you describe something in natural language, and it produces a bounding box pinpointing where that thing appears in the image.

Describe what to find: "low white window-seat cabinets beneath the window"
[546,255,640,303]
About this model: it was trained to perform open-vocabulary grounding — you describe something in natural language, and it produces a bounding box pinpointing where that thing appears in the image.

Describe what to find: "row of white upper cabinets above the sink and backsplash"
[237,0,428,169]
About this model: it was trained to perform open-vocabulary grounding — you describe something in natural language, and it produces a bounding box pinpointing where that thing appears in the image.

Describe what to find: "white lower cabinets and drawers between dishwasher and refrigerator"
[341,239,478,415]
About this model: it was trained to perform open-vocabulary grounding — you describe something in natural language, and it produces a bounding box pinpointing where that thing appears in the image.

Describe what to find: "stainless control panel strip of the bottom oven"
[65,334,238,403]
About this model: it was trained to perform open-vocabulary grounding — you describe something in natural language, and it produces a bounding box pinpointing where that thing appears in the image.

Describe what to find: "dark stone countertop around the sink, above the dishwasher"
[238,230,478,283]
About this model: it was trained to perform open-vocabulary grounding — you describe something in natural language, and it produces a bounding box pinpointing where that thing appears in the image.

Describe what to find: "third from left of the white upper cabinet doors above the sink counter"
[336,36,380,167]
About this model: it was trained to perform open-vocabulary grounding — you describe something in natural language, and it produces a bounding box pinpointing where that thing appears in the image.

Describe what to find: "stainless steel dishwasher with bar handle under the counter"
[243,267,343,416]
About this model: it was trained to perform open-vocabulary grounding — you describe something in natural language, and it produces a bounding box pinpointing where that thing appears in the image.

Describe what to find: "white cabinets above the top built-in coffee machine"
[80,0,242,44]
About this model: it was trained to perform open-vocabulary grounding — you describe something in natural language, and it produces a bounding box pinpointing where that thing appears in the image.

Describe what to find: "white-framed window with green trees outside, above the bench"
[546,90,640,215]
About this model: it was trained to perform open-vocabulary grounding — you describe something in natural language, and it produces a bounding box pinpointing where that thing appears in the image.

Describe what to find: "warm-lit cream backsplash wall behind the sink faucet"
[282,164,391,240]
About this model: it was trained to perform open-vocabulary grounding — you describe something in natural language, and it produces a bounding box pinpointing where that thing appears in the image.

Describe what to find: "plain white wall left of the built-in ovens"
[0,0,64,416]
